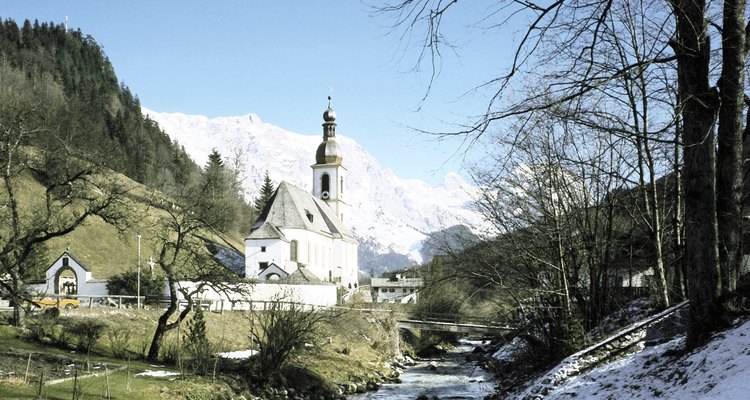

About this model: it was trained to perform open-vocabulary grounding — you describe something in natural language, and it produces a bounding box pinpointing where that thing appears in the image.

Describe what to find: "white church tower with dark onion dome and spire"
[312,96,346,222]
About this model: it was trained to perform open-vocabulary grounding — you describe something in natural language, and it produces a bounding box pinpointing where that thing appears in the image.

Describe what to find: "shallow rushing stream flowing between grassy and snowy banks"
[347,340,495,400]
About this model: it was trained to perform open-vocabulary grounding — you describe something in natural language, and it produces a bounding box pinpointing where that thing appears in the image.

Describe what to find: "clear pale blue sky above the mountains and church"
[0,0,512,184]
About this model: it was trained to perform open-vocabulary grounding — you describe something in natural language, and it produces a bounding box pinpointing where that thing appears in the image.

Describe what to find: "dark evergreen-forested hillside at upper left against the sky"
[0,20,197,187]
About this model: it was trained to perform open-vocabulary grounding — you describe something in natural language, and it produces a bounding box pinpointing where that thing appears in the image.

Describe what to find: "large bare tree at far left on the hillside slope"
[0,65,127,325]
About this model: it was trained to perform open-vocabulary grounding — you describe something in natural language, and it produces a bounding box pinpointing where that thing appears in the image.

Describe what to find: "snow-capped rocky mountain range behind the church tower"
[143,109,490,272]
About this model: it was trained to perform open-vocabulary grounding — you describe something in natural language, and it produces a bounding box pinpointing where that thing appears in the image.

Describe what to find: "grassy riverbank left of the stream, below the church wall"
[0,309,412,399]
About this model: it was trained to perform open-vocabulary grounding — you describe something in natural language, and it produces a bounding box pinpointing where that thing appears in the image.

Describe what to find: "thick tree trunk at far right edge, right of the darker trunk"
[717,0,745,295]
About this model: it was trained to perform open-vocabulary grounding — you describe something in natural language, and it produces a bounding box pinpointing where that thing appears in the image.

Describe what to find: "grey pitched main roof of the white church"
[249,182,354,241]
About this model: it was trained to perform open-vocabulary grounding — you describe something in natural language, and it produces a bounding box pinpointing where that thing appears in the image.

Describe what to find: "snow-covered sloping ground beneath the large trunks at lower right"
[536,320,750,400]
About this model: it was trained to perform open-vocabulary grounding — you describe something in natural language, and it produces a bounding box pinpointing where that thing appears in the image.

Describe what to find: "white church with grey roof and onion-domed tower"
[245,97,358,289]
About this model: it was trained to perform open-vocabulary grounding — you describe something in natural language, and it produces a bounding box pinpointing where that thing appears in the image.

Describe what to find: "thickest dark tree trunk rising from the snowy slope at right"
[672,0,724,348]
